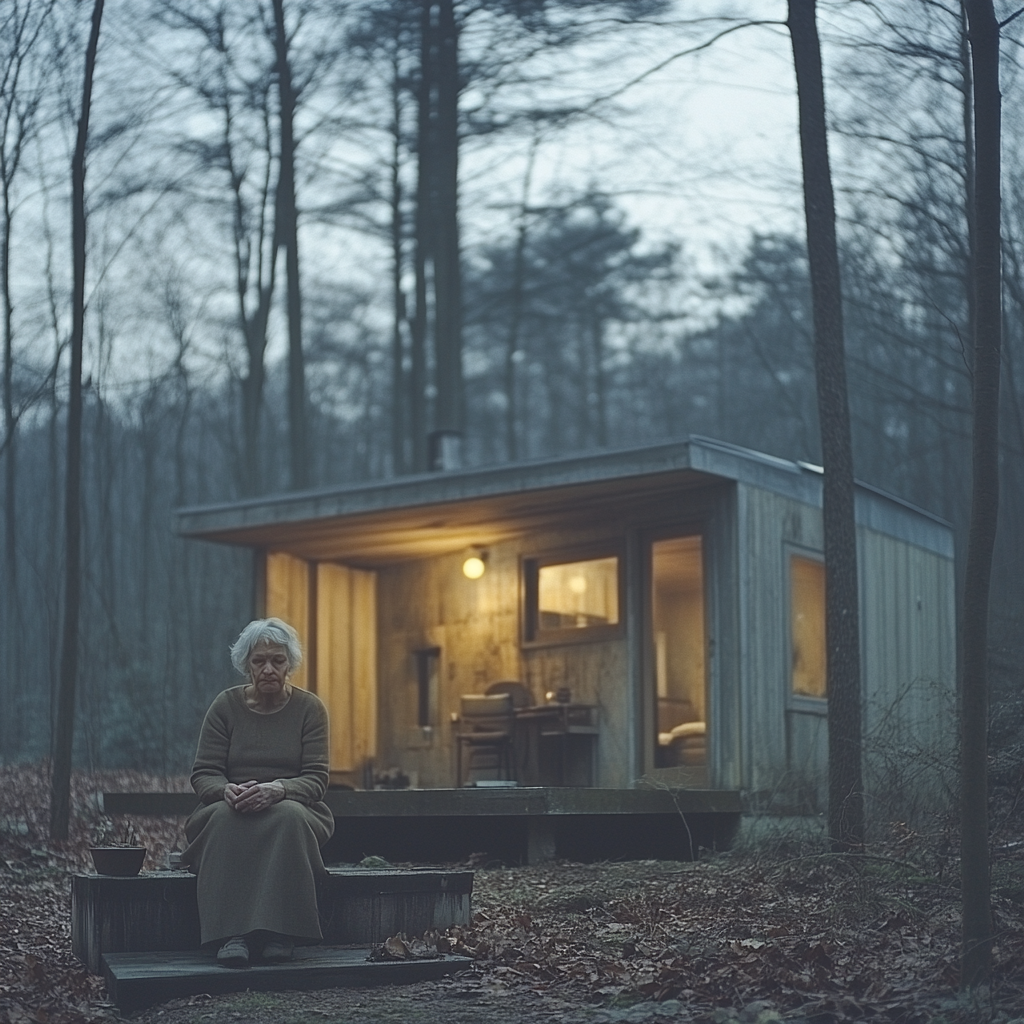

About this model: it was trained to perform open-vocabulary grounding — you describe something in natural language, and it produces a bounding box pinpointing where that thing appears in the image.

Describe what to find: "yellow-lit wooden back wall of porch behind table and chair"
[377,531,633,787]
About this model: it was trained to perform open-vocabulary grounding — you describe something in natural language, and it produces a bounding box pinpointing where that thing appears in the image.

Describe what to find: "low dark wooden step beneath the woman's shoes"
[102,946,473,1013]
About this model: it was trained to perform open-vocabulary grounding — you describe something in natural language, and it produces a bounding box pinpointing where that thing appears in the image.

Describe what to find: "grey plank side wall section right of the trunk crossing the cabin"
[858,529,956,822]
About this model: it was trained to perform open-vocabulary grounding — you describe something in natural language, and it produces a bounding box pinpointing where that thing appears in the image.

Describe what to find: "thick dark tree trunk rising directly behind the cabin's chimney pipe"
[434,0,465,468]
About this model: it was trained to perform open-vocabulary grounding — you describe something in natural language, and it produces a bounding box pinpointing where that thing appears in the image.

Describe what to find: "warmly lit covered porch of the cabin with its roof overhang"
[172,441,738,791]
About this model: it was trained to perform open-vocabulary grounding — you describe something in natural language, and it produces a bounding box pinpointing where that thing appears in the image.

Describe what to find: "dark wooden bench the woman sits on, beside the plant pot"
[72,867,473,974]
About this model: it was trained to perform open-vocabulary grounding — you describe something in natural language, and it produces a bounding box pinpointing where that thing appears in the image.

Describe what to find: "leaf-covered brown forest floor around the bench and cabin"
[0,765,1024,1024]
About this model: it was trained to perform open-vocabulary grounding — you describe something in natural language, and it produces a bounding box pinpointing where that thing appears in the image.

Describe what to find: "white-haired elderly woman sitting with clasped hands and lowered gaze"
[181,618,334,968]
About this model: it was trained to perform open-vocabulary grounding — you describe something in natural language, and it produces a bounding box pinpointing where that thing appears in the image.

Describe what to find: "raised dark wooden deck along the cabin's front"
[103,786,740,864]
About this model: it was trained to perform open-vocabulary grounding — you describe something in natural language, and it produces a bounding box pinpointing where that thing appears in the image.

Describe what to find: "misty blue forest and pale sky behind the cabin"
[0,0,1024,774]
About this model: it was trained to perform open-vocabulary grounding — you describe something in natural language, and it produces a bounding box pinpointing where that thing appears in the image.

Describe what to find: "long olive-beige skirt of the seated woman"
[181,800,334,945]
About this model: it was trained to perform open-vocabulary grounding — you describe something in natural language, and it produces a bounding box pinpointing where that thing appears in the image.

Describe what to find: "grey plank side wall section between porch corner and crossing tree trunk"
[738,484,828,813]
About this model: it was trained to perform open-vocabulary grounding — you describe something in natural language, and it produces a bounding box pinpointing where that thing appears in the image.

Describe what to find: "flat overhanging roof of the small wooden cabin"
[175,435,952,565]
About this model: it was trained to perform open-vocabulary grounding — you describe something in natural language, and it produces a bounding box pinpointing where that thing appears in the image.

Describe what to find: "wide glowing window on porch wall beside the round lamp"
[525,555,621,640]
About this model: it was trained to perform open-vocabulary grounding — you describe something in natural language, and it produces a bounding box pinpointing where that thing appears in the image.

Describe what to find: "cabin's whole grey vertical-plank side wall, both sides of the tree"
[738,485,955,819]
